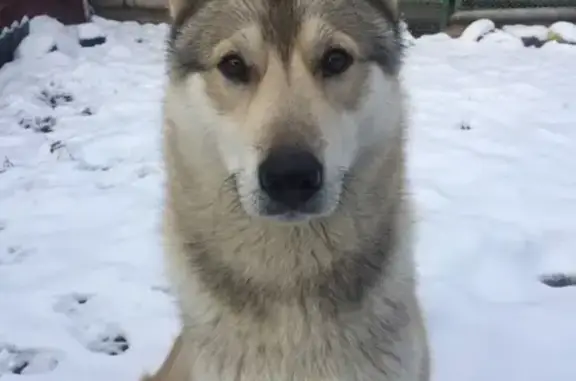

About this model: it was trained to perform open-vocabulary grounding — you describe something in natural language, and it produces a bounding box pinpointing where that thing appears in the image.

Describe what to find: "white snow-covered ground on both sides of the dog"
[0,14,576,381]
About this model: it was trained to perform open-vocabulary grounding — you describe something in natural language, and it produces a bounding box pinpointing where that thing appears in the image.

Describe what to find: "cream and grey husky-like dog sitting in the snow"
[143,0,431,381]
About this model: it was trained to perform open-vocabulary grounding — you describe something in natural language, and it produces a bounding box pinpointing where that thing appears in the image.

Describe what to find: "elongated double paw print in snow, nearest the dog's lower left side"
[54,293,130,356]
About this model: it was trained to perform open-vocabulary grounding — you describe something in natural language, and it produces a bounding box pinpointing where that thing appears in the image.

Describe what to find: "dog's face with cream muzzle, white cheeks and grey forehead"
[164,0,401,221]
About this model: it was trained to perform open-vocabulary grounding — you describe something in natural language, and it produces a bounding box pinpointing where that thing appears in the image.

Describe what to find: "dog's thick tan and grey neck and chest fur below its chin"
[166,164,421,381]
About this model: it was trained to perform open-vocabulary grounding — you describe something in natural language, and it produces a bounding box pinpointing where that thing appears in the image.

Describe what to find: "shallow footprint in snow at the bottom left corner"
[0,343,63,378]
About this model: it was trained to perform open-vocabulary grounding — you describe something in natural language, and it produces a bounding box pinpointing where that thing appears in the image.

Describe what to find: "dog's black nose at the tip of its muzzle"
[258,148,323,209]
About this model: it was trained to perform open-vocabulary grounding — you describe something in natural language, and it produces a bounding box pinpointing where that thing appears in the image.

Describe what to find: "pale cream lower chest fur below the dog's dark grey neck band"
[184,288,410,381]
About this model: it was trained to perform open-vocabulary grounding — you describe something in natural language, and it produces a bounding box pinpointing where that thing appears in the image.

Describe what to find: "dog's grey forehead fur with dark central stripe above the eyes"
[170,0,399,74]
